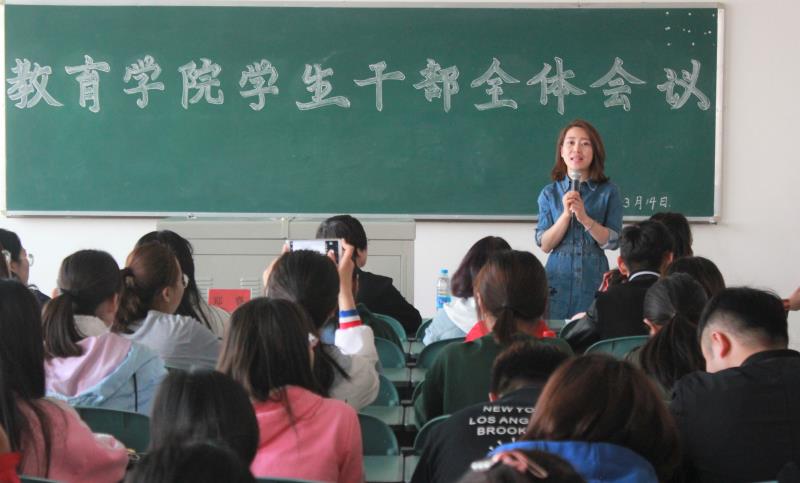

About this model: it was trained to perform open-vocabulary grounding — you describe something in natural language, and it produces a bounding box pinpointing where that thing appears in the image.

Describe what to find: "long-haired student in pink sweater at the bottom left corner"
[0,280,128,483]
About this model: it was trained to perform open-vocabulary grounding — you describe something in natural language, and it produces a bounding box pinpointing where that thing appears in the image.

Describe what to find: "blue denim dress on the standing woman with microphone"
[536,177,622,319]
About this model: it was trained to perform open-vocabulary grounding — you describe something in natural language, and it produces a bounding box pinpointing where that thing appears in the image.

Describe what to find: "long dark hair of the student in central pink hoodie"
[217,297,322,404]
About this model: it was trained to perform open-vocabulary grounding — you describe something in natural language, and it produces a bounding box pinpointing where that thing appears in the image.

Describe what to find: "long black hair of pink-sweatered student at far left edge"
[0,280,52,475]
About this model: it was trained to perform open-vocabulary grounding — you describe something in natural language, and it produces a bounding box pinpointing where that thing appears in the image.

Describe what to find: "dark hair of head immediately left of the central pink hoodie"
[149,371,258,465]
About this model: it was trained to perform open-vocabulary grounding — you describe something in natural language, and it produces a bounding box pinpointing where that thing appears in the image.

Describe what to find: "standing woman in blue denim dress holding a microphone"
[536,119,622,319]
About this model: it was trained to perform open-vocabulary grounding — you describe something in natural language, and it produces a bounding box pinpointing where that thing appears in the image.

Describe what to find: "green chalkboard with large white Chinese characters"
[5,5,722,218]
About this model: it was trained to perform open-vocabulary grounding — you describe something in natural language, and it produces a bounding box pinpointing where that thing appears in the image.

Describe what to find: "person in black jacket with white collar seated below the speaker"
[561,221,672,354]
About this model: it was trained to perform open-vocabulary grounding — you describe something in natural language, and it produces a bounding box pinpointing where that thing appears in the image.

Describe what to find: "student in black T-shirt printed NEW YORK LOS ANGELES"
[411,339,569,483]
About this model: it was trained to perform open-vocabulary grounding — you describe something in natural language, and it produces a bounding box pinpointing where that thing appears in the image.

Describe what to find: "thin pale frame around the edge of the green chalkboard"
[0,0,725,224]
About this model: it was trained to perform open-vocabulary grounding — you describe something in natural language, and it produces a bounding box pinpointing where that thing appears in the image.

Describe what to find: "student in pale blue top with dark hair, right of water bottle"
[422,236,511,345]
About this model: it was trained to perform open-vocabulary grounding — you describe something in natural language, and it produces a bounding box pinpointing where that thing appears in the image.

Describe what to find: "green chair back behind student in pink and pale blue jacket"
[75,406,150,453]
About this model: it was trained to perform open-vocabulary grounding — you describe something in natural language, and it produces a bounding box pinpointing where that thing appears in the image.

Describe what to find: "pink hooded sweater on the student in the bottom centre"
[250,386,364,483]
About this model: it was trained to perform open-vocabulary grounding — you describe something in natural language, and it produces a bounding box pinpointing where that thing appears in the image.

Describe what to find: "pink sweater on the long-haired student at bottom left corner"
[20,400,128,483]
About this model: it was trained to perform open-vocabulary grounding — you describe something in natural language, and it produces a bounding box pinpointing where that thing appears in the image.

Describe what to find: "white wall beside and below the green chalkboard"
[0,0,800,347]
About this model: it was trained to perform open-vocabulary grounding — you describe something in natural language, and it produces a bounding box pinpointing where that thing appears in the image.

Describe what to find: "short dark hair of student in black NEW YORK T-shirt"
[489,338,570,395]
